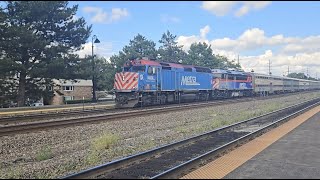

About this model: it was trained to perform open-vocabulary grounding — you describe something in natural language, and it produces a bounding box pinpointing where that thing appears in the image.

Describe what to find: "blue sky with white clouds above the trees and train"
[69,1,320,78]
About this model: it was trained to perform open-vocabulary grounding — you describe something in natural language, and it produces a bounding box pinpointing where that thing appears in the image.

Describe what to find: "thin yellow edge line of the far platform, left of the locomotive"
[0,104,114,115]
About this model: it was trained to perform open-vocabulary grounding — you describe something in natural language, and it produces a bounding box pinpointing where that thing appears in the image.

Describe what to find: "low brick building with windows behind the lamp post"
[50,79,92,105]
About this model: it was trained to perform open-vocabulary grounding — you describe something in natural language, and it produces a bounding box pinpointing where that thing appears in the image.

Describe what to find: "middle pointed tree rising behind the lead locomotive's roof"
[157,31,187,63]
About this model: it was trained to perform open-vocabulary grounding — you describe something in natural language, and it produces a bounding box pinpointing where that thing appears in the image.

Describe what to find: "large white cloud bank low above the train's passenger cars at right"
[177,26,320,77]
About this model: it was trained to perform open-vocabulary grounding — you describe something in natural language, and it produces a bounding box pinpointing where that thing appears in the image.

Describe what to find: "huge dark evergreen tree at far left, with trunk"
[0,1,91,106]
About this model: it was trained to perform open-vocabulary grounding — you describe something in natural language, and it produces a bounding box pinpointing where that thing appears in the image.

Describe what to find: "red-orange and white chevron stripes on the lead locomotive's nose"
[114,72,139,90]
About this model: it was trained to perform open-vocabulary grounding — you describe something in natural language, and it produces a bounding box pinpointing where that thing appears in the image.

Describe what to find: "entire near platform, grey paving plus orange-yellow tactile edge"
[182,106,320,179]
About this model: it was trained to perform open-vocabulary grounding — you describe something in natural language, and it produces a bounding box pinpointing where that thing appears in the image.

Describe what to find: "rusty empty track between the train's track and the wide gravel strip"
[0,91,318,137]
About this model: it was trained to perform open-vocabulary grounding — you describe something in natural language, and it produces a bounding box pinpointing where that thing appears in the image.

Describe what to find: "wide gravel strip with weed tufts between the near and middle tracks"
[0,92,320,178]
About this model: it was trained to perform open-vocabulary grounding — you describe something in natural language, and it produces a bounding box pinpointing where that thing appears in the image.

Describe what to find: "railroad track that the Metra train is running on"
[0,92,316,125]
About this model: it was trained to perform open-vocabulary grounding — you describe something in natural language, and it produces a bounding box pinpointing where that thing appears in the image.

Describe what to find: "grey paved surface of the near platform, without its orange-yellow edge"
[224,112,320,179]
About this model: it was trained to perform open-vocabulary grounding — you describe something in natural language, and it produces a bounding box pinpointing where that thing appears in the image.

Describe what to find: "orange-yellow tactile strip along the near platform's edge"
[181,106,320,179]
